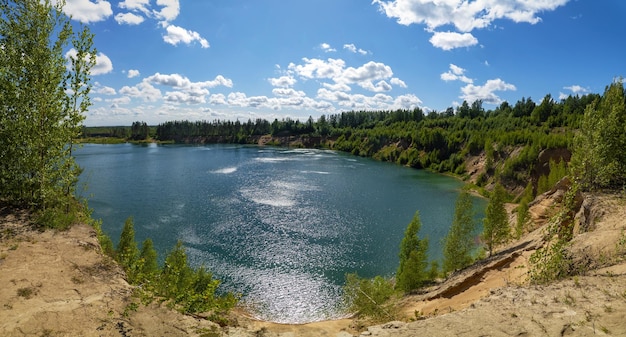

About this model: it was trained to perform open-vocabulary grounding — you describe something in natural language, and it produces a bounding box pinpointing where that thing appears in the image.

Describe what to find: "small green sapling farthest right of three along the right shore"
[482,184,511,256]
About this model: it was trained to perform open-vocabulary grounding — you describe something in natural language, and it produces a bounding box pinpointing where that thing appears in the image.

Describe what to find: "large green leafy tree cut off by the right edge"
[571,79,626,189]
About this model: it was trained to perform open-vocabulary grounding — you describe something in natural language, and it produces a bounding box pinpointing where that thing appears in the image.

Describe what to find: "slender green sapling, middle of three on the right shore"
[443,191,476,274]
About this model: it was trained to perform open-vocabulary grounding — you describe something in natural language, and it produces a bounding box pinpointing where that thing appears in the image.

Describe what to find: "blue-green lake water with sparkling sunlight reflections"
[76,144,485,323]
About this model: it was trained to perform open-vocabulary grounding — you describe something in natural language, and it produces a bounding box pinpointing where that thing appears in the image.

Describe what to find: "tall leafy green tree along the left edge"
[0,0,95,226]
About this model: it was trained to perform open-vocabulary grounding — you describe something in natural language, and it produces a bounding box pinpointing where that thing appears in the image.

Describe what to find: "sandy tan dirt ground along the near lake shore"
[0,192,626,337]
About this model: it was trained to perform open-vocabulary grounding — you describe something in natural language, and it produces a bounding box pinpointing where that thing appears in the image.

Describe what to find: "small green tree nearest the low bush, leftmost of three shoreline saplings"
[396,212,428,293]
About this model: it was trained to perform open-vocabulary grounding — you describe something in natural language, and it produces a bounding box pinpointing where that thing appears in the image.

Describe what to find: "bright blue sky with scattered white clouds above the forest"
[56,0,626,126]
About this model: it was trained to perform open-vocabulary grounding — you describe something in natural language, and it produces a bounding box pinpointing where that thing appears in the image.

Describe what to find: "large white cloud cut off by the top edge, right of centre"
[372,0,569,32]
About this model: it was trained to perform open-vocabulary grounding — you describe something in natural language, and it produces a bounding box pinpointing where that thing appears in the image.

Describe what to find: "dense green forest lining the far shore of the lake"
[83,94,602,194]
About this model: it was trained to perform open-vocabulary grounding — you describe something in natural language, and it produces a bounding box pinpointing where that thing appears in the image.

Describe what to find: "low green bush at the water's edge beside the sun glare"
[343,273,397,323]
